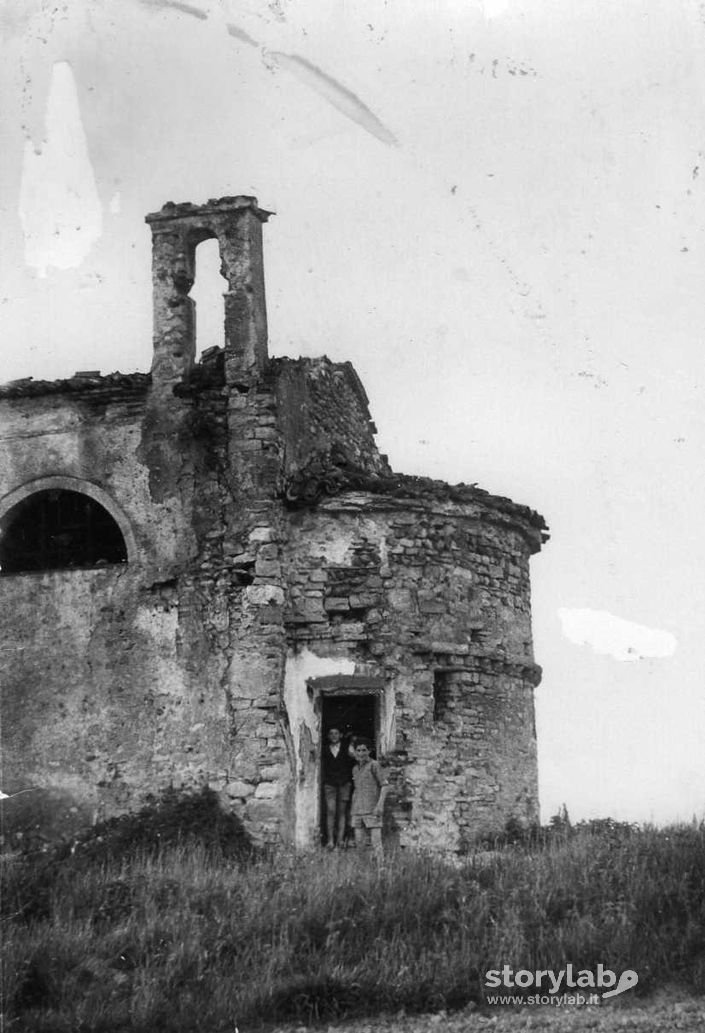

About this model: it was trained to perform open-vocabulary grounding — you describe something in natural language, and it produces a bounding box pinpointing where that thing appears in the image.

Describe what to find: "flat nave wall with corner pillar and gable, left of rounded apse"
[0,350,394,838]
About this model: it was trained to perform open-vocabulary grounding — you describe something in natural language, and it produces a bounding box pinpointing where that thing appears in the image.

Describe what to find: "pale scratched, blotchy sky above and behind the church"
[0,0,705,822]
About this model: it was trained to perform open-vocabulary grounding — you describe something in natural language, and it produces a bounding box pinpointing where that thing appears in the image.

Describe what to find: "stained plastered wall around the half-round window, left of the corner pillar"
[0,378,235,834]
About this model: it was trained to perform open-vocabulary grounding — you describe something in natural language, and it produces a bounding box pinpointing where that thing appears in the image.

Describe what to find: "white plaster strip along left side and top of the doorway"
[284,649,355,847]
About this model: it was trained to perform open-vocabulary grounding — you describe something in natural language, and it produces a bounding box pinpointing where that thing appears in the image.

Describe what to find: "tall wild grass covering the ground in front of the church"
[2,824,705,1033]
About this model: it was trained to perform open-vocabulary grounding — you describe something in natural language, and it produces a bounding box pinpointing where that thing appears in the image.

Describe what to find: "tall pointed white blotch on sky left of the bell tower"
[20,61,102,276]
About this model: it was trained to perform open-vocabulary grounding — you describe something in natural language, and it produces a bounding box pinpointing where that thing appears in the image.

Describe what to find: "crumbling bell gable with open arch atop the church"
[146,196,271,394]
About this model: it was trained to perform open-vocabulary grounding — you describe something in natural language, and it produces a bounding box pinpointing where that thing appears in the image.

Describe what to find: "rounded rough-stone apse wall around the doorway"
[277,489,541,848]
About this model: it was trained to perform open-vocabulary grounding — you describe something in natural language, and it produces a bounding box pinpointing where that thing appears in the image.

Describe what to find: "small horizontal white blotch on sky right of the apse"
[558,607,677,662]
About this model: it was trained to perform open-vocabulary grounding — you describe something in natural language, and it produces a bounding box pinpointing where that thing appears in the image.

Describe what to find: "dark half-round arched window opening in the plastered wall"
[0,490,127,575]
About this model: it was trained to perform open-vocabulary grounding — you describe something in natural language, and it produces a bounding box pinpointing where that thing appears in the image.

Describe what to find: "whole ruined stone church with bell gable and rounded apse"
[0,196,547,849]
